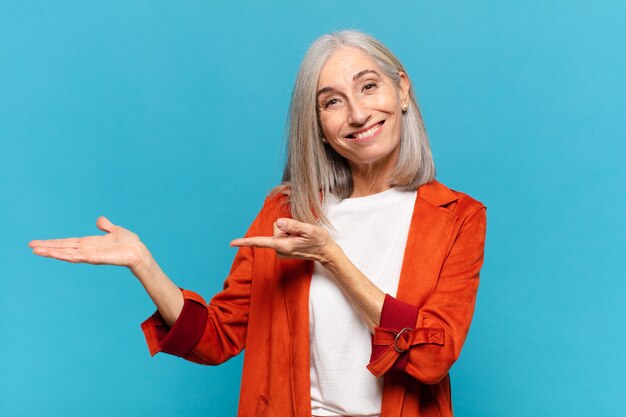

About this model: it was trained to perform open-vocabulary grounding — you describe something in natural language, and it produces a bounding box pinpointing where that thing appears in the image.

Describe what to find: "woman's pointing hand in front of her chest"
[230,218,339,264]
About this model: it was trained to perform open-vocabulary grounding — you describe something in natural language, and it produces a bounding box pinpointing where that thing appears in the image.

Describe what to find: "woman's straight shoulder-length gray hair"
[277,30,435,225]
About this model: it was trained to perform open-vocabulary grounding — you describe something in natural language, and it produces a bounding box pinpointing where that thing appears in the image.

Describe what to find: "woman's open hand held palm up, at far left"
[28,216,149,271]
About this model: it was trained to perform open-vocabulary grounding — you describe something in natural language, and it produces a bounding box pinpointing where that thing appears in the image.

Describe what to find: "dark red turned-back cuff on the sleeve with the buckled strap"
[370,294,419,371]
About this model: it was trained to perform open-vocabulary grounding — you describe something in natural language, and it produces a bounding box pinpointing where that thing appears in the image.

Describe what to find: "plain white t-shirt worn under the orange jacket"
[309,188,417,417]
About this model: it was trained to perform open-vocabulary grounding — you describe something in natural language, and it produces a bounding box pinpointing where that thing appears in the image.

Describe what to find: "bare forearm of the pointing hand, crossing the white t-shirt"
[321,245,385,333]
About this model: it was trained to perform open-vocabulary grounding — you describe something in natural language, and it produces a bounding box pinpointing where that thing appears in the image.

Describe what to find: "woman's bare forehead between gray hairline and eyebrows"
[317,47,383,89]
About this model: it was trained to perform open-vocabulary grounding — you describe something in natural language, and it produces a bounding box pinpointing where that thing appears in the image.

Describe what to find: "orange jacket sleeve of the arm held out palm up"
[141,198,263,365]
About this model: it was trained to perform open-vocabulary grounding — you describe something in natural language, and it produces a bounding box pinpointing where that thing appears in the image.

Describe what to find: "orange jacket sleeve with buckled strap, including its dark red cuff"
[368,205,486,384]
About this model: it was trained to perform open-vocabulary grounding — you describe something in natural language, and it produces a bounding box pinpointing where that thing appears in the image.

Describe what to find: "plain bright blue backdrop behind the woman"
[0,0,626,417]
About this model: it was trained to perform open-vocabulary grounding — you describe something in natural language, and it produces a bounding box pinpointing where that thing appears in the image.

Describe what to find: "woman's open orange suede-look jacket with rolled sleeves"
[142,181,486,417]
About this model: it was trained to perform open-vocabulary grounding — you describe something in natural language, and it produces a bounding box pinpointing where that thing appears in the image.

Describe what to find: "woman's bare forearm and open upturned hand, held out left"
[28,217,184,326]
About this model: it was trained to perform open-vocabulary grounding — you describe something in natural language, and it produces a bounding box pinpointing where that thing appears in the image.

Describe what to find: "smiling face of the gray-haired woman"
[317,48,409,168]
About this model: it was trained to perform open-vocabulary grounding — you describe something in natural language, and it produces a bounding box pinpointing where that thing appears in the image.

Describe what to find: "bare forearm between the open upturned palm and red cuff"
[131,247,184,326]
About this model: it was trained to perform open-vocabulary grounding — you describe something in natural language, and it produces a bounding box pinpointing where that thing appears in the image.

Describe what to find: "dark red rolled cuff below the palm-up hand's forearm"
[141,290,207,356]
